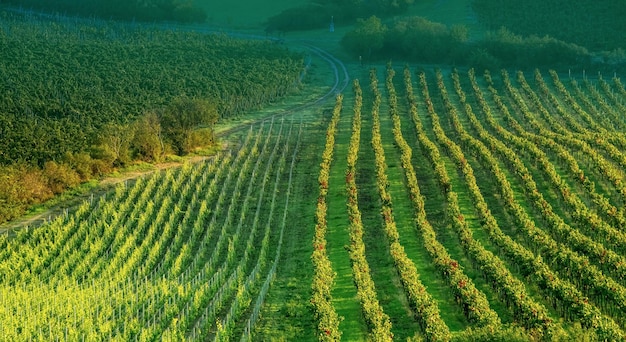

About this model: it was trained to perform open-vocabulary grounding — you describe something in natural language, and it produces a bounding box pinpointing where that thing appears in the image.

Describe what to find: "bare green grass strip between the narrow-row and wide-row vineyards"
[249,117,316,341]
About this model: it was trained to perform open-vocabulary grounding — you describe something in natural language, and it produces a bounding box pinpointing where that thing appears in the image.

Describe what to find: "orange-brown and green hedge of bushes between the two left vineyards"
[0,97,218,222]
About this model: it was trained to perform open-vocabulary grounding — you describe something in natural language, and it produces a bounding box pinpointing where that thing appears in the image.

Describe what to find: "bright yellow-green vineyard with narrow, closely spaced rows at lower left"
[0,114,304,341]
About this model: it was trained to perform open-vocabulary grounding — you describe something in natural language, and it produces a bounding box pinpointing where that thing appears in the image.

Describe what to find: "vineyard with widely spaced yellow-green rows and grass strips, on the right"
[311,64,626,341]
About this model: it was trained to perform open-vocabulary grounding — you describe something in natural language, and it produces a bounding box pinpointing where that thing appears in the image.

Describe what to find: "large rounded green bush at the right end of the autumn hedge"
[161,97,219,154]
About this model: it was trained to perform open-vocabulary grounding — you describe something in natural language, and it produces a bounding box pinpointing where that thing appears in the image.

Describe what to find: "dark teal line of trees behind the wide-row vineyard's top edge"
[341,16,593,70]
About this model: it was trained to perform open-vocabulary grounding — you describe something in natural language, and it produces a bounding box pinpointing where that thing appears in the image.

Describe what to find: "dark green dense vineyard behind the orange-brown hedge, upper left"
[0,12,304,166]
